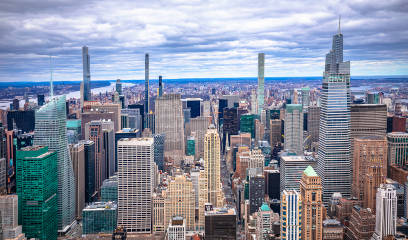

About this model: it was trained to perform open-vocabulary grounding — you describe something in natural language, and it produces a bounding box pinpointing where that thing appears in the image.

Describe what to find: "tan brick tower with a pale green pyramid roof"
[300,166,324,240]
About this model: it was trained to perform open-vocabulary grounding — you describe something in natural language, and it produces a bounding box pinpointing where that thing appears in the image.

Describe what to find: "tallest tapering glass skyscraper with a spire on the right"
[317,21,351,204]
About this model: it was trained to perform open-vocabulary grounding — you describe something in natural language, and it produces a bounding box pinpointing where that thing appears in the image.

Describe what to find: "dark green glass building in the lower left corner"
[16,146,58,240]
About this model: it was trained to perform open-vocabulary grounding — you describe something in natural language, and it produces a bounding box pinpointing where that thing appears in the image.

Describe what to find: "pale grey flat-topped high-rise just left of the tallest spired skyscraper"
[284,104,303,155]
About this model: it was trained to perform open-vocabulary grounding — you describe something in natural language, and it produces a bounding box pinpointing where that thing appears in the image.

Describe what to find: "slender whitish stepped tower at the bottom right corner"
[373,184,397,239]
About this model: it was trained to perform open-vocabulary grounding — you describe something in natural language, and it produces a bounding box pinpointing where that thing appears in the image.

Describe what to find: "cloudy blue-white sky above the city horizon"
[0,0,408,81]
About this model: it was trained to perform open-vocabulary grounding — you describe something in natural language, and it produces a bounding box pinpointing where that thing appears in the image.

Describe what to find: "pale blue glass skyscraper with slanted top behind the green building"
[34,96,75,232]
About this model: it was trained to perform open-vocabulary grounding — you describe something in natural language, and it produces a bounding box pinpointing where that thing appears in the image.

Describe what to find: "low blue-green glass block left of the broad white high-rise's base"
[82,202,118,235]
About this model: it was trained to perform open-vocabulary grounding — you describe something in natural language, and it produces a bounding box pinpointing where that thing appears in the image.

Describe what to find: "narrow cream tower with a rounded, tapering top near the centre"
[204,125,222,207]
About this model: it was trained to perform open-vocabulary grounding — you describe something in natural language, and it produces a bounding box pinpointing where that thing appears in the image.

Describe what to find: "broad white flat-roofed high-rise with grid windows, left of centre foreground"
[117,138,154,233]
